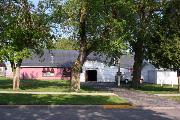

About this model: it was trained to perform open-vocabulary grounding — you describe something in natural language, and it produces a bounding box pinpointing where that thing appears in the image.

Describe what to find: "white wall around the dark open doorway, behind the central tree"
[80,61,128,82]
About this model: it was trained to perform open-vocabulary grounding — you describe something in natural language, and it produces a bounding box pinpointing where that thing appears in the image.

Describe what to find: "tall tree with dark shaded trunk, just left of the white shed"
[109,0,162,87]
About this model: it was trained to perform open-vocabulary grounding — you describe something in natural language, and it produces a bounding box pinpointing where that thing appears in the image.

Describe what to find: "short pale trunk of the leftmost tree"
[13,63,21,90]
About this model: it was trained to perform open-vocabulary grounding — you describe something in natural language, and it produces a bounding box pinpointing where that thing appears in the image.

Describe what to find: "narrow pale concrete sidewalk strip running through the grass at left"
[0,91,118,96]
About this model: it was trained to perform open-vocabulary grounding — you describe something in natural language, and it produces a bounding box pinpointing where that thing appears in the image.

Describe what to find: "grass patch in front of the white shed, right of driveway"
[136,83,178,94]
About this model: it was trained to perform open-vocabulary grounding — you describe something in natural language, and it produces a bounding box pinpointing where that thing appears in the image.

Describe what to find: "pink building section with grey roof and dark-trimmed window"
[20,50,78,80]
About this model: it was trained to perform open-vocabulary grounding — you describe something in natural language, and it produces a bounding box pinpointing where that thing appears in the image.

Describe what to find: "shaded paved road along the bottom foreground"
[0,106,180,120]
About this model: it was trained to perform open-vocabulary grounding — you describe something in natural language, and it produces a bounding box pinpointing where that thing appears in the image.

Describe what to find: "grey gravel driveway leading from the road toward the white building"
[82,82,180,107]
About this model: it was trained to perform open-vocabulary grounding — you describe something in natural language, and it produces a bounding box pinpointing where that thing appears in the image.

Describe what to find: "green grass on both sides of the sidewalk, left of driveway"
[0,77,129,105]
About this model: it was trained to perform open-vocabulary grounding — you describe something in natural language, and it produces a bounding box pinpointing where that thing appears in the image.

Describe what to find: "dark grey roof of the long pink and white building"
[21,50,134,68]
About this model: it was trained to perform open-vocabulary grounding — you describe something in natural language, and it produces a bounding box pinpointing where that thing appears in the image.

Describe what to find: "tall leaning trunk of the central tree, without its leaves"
[71,0,88,91]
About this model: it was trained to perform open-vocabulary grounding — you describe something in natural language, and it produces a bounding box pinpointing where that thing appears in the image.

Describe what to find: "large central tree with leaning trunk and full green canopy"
[54,0,127,91]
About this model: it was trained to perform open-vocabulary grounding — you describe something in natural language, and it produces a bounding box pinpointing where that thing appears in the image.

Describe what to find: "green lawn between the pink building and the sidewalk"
[0,77,97,92]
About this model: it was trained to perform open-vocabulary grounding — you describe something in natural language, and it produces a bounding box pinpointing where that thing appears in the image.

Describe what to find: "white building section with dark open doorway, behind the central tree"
[80,55,133,82]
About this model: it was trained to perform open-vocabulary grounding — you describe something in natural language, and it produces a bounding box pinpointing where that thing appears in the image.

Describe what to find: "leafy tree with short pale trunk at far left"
[0,0,53,90]
